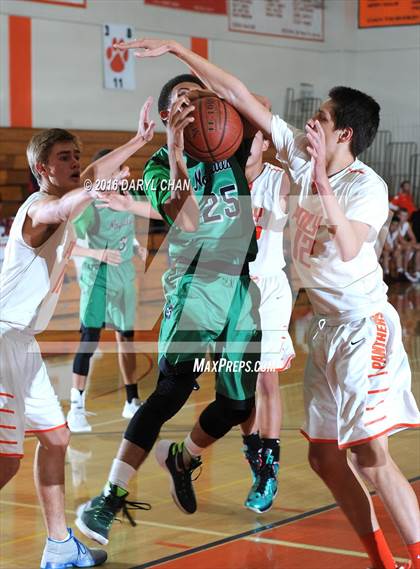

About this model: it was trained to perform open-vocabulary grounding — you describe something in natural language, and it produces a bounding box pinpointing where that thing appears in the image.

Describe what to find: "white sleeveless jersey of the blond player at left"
[0,192,75,334]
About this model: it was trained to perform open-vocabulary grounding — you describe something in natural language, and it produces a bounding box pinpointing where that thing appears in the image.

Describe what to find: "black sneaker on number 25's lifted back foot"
[155,441,201,514]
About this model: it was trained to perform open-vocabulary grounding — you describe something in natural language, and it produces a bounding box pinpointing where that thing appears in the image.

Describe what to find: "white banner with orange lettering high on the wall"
[229,0,324,41]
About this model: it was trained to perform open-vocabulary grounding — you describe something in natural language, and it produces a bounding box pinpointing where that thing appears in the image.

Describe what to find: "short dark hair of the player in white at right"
[328,86,381,157]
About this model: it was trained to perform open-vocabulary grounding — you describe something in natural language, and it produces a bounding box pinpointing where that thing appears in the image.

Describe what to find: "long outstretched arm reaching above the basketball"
[117,39,272,137]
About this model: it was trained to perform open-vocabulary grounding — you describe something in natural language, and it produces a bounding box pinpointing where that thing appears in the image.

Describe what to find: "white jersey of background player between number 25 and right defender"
[249,163,287,277]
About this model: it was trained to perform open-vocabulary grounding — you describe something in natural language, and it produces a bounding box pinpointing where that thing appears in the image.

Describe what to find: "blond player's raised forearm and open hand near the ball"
[81,97,155,182]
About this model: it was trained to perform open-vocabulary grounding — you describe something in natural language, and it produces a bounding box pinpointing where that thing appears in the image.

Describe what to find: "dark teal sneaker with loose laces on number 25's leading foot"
[76,484,151,545]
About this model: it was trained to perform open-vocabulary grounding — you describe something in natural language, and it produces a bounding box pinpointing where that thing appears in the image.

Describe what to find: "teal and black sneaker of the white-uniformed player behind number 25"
[245,449,279,514]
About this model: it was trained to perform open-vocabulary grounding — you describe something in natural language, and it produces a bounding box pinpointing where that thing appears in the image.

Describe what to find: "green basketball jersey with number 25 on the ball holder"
[143,146,257,265]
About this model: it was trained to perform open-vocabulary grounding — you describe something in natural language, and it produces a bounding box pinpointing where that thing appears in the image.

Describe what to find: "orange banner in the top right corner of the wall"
[359,0,420,28]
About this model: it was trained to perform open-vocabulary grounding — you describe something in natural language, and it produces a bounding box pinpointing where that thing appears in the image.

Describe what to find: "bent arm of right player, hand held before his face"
[306,121,370,262]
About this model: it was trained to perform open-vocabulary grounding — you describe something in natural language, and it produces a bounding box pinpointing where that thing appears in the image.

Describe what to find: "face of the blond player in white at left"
[41,142,80,191]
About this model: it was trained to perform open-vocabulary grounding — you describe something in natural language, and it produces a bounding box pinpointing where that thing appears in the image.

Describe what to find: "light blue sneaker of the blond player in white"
[41,528,107,569]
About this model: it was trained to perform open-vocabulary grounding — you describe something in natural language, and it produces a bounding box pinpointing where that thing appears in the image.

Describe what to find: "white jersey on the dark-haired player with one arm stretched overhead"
[271,116,388,319]
